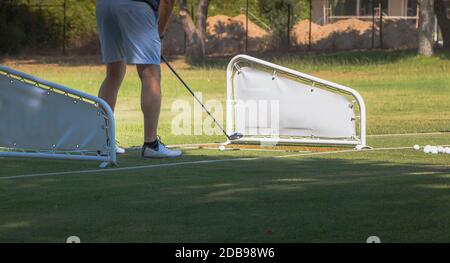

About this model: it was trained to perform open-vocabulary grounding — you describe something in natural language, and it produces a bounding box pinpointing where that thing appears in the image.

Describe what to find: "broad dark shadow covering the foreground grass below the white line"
[0,151,450,242]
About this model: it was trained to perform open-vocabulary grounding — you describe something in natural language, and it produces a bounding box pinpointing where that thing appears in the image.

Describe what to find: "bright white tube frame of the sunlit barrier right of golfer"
[226,55,367,149]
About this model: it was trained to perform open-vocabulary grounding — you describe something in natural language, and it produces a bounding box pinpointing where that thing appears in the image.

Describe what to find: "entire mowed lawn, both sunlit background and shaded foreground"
[0,52,450,242]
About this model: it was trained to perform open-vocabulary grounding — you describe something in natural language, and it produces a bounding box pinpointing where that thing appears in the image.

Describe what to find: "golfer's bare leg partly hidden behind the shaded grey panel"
[98,62,127,111]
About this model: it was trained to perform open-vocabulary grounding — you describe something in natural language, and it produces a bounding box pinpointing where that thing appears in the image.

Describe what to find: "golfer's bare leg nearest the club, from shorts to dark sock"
[137,65,161,143]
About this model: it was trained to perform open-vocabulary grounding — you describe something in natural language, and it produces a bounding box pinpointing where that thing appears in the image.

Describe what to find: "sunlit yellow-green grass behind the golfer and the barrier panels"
[7,51,450,146]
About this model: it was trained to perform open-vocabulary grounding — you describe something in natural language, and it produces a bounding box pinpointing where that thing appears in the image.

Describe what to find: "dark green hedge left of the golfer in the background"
[0,0,96,55]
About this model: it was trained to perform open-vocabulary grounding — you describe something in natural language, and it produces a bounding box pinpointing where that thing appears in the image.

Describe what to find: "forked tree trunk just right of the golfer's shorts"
[179,0,209,60]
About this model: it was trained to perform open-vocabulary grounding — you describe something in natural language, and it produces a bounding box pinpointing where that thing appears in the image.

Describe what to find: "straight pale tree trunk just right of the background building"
[419,0,434,56]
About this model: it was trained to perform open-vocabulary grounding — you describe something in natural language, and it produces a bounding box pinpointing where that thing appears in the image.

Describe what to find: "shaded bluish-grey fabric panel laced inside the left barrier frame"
[0,71,114,158]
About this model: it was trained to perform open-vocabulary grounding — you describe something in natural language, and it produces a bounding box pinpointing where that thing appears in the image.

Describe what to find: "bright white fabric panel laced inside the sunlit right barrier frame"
[233,66,357,140]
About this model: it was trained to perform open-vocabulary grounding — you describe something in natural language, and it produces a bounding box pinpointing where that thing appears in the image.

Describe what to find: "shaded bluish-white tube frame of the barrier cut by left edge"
[0,65,117,167]
